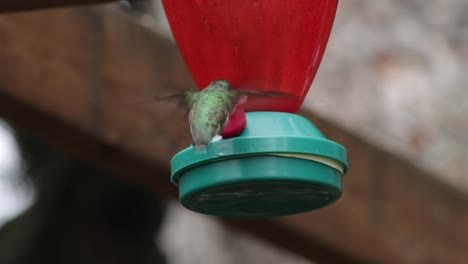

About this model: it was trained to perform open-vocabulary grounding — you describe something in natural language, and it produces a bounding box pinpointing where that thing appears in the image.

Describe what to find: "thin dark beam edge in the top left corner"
[0,0,144,13]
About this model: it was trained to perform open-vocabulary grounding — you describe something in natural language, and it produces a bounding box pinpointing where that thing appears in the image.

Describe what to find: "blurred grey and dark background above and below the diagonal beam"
[0,0,468,264]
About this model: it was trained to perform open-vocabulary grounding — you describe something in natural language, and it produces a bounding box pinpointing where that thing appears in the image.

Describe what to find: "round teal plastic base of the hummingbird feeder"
[171,112,348,218]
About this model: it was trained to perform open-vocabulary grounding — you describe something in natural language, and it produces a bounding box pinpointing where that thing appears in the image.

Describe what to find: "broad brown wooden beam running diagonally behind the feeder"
[0,6,468,263]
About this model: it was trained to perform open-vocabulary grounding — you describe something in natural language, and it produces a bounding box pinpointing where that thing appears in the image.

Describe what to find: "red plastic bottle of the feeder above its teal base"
[163,0,338,113]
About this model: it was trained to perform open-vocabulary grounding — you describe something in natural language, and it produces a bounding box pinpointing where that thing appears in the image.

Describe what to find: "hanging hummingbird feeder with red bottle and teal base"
[163,0,348,218]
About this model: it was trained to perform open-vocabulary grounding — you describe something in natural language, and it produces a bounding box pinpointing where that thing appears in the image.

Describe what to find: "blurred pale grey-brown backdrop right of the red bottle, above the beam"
[306,0,468,190]
